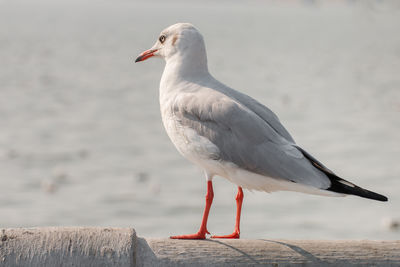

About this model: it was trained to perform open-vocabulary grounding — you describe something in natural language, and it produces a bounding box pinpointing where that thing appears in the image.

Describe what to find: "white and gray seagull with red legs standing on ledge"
[135,23,388,239]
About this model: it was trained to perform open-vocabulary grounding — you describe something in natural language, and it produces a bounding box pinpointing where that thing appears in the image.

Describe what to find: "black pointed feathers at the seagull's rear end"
[296,146,388,201]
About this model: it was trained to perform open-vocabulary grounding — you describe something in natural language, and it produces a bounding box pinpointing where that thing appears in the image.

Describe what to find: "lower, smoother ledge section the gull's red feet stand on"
[137,238,400,267]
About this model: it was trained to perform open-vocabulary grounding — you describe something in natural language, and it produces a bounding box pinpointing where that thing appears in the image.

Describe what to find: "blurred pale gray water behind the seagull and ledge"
[0,0,400,239]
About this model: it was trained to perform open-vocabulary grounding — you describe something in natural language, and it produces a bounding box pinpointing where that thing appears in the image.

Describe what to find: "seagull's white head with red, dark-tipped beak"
[135,23,208,75]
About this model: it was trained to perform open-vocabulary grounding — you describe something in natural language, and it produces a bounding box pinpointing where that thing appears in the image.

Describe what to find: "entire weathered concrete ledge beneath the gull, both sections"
[0,227,400,267]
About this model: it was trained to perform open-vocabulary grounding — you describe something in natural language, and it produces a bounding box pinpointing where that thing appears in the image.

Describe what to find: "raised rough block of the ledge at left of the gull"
[0,227,136,267]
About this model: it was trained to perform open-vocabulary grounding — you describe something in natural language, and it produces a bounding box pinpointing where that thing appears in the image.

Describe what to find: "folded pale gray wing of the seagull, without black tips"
[174,88,330,189]
